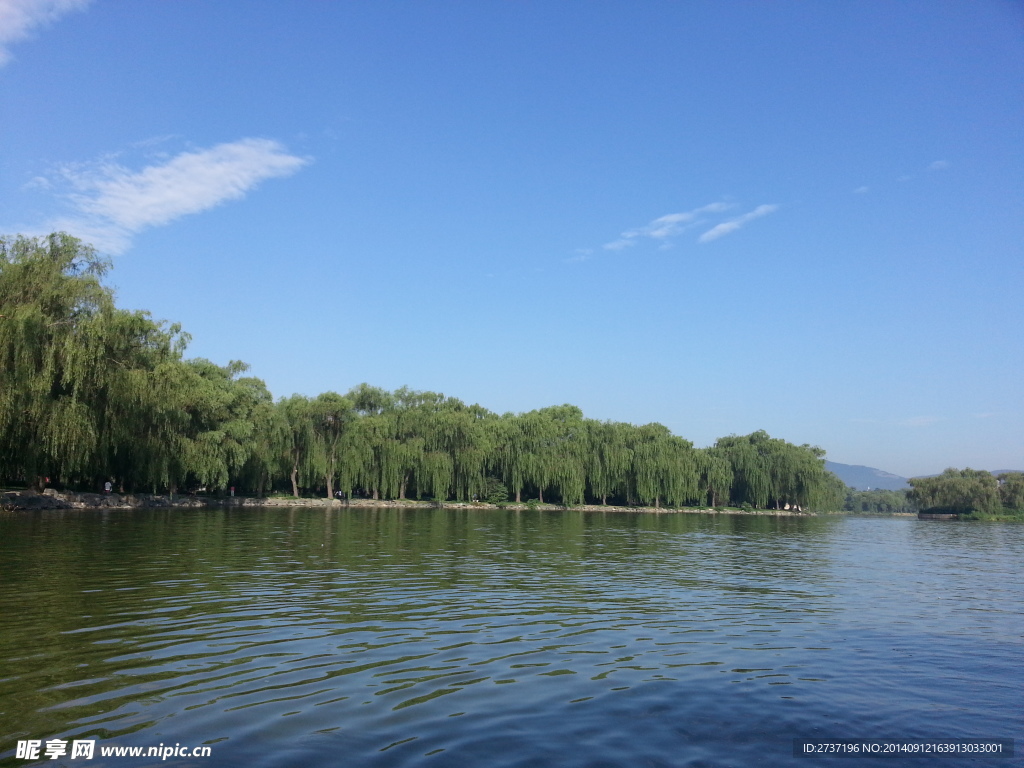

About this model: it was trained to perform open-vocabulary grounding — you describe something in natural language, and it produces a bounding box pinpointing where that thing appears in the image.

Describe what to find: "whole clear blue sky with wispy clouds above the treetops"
[0,0,1024,475]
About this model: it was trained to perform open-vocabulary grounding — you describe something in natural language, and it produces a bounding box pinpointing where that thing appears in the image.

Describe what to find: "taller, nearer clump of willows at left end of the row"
[0,234,283,490]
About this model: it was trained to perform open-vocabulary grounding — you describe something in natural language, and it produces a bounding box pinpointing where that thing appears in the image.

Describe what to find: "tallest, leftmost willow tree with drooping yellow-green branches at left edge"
[0,233,186,483]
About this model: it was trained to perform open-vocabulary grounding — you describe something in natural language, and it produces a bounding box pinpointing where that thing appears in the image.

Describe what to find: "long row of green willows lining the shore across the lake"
[0,233,846,510]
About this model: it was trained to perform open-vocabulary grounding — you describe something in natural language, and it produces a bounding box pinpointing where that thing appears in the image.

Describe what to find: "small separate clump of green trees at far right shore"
[909,469,1024,517]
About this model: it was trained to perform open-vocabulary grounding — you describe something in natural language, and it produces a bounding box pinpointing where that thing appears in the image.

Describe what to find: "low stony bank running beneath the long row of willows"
[0,488,814,516]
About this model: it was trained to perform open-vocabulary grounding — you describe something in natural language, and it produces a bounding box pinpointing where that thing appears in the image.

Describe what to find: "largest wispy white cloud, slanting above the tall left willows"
[37,138,309,253]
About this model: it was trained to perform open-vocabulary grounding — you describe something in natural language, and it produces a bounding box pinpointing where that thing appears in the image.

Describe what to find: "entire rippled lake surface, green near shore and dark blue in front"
[0,508,1024,768]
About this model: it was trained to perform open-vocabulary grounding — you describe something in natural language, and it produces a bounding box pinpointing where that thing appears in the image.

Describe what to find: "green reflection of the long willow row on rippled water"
[0,508,847,749]
